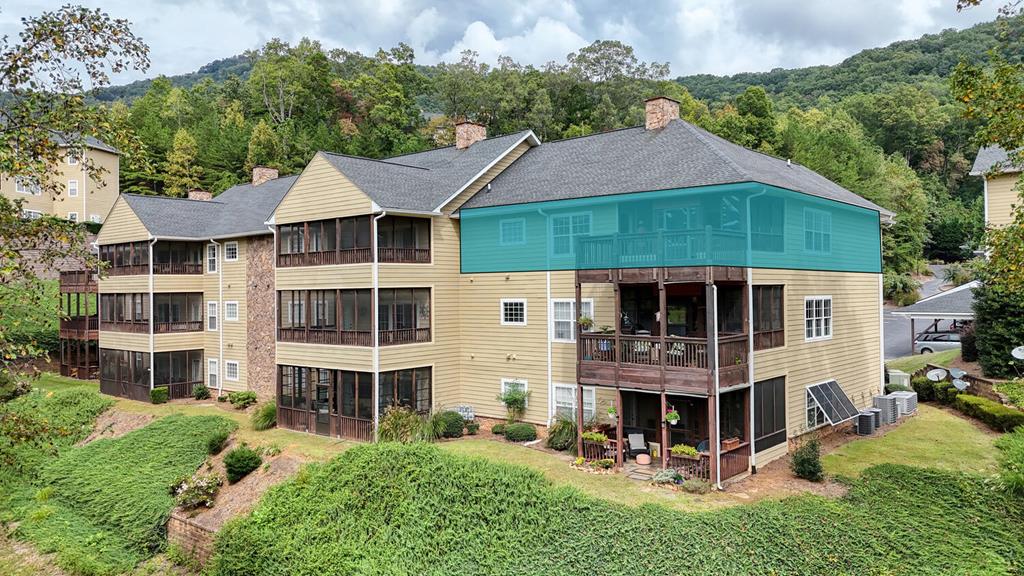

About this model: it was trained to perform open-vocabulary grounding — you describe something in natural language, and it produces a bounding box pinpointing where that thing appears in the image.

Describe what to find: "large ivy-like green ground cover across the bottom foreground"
[209,444,1024,576]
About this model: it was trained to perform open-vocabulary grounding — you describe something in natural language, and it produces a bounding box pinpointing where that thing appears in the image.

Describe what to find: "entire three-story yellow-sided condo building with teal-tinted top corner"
[88,98,891,482]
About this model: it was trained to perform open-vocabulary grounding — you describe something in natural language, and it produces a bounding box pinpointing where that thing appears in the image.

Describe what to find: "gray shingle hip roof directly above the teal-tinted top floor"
[464,120,892,215]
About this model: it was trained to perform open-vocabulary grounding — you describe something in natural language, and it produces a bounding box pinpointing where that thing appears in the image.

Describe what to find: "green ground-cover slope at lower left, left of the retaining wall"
[16,414,237,574]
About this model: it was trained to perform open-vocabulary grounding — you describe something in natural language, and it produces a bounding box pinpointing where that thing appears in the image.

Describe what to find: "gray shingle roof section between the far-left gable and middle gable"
[123,176,298,239]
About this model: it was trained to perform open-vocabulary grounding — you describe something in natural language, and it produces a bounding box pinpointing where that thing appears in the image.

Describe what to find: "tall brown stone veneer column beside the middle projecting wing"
[246,236,278,400]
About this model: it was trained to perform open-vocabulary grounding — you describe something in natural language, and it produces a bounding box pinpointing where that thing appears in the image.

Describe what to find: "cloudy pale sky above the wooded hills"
[0,0,1004,83]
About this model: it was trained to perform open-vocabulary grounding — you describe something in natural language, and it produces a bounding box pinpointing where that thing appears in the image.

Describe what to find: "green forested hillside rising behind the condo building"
[99,18,1021,297]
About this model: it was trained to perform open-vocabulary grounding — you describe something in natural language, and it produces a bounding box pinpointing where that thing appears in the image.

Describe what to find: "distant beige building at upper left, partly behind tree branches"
[0,137,120,223]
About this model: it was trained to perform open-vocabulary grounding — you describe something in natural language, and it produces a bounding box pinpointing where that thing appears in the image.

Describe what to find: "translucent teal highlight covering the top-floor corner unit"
[460,182,882,274]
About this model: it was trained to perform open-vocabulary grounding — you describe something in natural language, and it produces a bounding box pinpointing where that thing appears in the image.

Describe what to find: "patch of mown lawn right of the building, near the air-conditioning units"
[822,404,997,477]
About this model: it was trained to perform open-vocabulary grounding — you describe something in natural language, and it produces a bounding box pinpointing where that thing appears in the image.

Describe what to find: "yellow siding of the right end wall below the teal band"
[753,270,882,464]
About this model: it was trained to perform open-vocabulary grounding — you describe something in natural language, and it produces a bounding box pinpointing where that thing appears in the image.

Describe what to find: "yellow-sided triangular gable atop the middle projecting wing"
[274,154,373,224]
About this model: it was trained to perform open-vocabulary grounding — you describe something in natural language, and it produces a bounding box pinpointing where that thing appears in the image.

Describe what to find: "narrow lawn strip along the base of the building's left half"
[36,373,354,460]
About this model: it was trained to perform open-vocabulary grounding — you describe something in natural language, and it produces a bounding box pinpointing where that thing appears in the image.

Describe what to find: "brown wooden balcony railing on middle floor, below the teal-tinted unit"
[578,333,748,395]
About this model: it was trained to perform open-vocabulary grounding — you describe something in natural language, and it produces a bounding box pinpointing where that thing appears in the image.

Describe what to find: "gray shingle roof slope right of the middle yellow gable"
[322,130,530,211]
